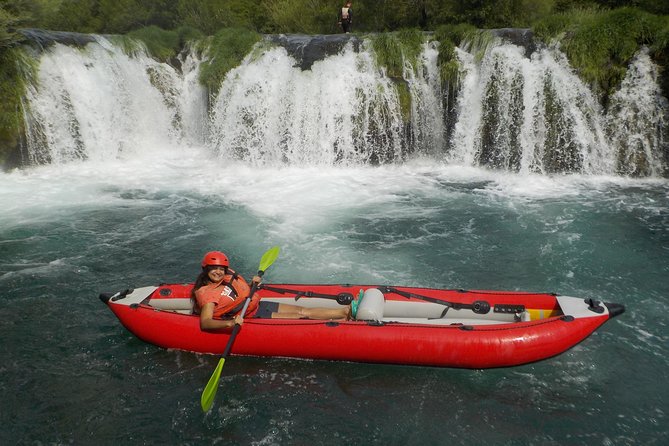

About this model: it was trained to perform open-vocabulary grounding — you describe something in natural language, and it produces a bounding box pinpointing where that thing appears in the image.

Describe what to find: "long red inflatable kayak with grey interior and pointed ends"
[100,284,625,369]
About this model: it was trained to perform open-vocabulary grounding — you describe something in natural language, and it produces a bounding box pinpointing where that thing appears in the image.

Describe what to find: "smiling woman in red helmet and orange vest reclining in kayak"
[193,251,351,330]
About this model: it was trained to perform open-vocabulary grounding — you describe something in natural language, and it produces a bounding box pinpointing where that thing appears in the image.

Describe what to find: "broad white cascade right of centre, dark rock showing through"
[449,42,614,173]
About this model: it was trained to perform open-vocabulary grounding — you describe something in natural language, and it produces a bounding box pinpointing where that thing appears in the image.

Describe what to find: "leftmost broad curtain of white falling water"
[26,37,206,163]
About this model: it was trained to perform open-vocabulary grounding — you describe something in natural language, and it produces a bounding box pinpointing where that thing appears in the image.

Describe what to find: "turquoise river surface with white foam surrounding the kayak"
[0,148,669,445]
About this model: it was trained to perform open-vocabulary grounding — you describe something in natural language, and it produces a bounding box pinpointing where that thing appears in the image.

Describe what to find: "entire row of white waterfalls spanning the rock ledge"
[18,31,669,176]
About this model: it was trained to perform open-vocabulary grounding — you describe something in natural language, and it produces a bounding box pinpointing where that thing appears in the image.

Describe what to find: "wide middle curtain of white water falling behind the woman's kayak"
[211,39,403,165]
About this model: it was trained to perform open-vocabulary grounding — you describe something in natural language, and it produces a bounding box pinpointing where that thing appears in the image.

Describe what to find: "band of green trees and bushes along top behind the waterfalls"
[0,0,669,39]
